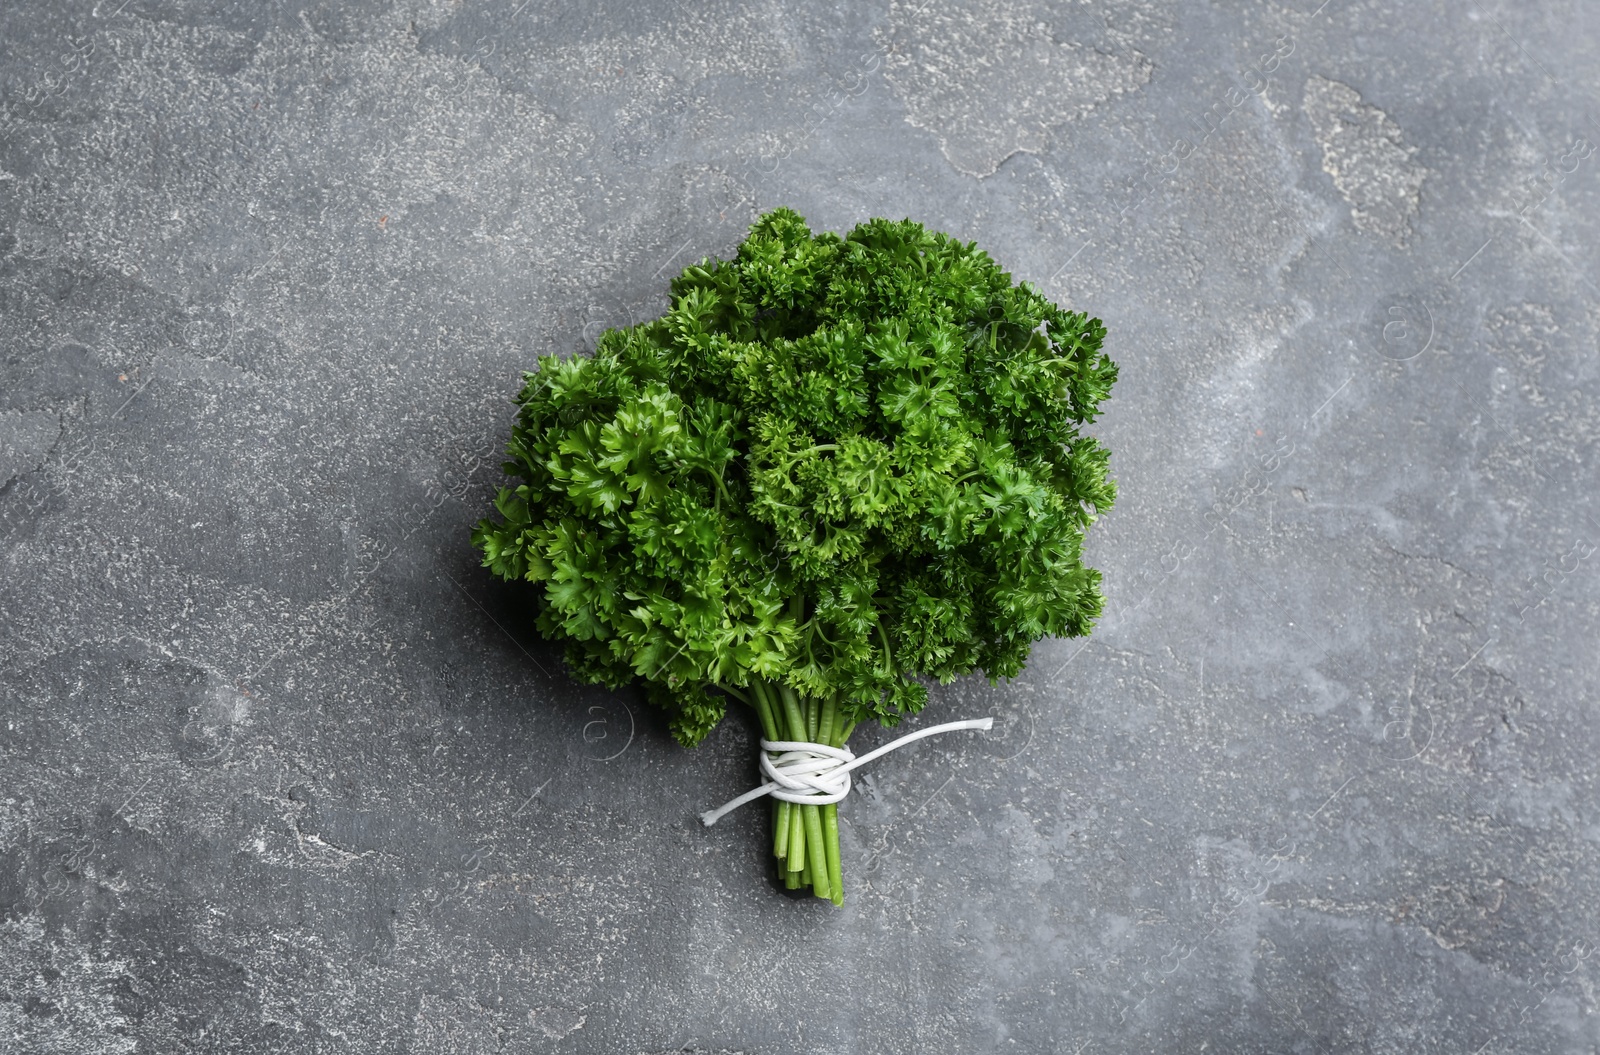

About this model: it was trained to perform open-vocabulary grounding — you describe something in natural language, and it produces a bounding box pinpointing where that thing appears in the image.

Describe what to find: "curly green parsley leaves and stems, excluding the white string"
[472,208,1117,903]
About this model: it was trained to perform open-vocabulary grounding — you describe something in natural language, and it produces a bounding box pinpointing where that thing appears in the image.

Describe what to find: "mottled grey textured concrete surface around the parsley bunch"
[0,0,1600,1055]
